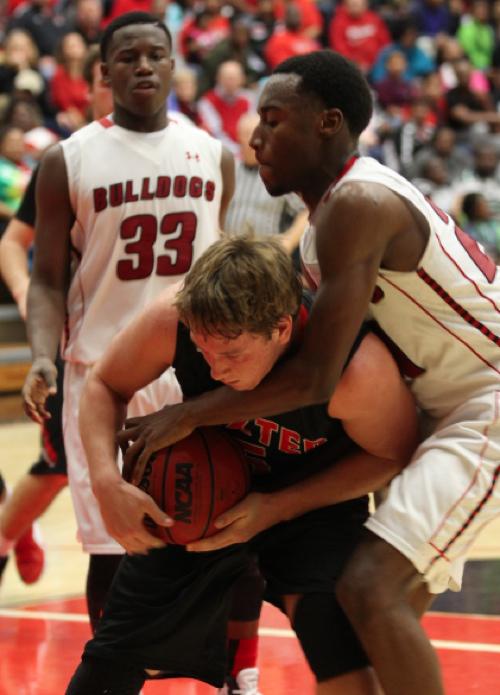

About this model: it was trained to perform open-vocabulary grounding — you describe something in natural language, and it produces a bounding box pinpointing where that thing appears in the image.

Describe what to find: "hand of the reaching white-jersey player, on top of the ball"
[116,403,194,485]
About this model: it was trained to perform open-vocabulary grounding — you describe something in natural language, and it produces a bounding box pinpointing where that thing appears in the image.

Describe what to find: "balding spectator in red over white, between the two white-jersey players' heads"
[198,60,255,154]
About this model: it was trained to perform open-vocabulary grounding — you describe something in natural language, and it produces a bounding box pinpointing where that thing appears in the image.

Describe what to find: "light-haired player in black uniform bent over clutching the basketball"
[67,239,416,695]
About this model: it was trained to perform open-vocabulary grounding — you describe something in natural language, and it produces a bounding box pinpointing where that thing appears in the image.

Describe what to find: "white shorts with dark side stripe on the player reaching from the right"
[366,391,500,594]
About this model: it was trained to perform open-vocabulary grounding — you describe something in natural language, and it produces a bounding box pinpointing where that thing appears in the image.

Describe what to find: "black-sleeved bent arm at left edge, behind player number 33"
[0,170,36,320]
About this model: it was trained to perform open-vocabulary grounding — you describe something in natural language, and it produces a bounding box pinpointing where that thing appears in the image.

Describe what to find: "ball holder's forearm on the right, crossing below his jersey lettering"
[272,451,405,521]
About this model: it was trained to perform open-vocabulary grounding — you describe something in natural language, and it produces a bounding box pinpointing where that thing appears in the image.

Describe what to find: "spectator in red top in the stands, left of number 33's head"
[50,32,90,132]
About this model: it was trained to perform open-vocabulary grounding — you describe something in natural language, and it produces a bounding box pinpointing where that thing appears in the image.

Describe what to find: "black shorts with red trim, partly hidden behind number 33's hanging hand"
[29,357,67,475]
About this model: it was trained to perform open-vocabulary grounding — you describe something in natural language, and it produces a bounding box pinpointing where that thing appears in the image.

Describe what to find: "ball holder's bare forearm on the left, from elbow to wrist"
[79,372,127,499]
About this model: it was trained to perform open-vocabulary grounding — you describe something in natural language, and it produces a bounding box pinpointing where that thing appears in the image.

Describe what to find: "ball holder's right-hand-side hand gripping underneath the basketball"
[187,492,283,552]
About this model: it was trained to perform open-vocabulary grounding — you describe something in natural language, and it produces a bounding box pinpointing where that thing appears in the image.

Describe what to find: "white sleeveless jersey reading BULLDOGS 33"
[61,118,223,364]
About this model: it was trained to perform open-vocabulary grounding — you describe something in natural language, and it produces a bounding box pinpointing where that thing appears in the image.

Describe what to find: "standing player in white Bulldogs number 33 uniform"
[24,13,234,624]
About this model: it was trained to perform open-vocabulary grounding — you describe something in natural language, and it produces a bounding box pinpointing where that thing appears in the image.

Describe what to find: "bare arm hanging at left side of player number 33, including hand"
[23,145,74,422]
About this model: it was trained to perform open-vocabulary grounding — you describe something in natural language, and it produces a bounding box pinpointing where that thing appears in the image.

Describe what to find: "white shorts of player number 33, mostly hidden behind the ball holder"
[63,362,182,555]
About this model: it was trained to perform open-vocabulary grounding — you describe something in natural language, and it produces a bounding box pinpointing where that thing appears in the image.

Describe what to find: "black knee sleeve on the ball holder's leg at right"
[293,593,368,683]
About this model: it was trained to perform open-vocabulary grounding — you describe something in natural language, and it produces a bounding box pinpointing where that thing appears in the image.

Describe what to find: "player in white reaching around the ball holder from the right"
[123,51,500,695]
